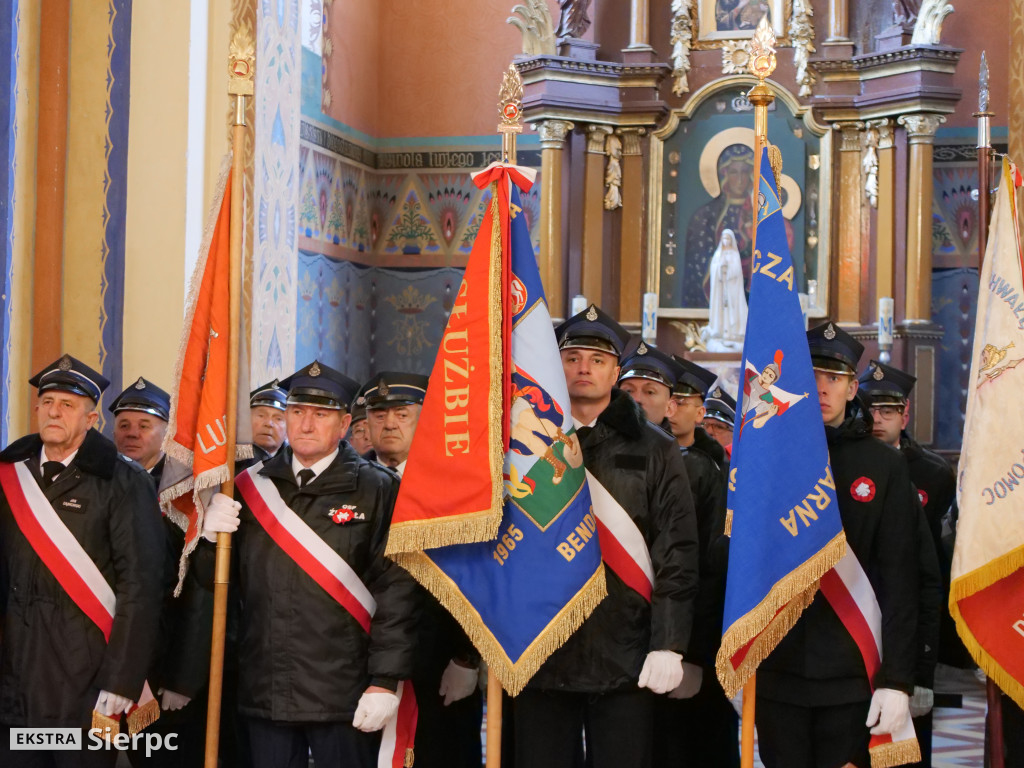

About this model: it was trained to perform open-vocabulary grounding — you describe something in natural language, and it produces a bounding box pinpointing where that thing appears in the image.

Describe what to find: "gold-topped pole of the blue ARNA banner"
[739,16,778,768]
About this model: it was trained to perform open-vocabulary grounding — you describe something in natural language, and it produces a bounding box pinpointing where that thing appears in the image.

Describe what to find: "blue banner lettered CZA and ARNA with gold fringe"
[717,150,846,696]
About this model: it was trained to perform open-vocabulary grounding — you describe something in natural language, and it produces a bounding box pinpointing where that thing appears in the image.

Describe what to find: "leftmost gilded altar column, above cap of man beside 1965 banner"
[537,120,572,317]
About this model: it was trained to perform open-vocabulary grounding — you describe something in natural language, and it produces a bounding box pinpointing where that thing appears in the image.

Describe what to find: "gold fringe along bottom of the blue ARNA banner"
[715,530,846,698]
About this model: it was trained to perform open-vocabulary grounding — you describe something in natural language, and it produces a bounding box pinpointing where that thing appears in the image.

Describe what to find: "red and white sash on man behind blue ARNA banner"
[821,548,921,768]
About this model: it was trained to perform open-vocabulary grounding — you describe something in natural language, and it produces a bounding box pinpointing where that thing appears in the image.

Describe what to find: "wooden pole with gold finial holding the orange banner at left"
[204,27,255,768]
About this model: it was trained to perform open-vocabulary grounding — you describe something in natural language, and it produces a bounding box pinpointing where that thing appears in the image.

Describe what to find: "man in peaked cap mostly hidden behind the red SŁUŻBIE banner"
[362,372,483,768]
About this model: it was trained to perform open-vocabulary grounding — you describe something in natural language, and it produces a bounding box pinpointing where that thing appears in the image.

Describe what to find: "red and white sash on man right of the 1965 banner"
[587,470,654,602]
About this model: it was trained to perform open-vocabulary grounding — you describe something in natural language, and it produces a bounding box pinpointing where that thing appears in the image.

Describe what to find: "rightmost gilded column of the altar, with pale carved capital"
[899,113,946,323]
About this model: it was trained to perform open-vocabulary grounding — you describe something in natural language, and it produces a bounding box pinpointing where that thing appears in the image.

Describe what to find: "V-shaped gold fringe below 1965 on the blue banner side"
[393,552,607,696]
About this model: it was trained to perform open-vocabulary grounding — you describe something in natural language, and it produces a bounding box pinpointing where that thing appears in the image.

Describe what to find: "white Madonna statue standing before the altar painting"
[701,229,746,352]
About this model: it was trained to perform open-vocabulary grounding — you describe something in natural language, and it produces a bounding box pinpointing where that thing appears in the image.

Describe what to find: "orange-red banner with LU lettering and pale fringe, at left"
[160,159,252,589]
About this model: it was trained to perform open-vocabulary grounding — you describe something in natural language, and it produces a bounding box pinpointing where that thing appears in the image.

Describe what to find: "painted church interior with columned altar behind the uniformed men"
[0,0,1007,455]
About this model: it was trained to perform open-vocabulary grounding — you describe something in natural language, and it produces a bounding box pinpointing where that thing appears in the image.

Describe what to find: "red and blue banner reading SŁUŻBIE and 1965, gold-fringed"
[388,166,602,695]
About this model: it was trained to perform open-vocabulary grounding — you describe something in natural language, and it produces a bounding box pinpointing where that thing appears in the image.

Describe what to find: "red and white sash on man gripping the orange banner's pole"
[234,462,417,768]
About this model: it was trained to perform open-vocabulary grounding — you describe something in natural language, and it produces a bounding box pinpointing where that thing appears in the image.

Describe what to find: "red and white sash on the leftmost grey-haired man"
[0,461,160,733]
